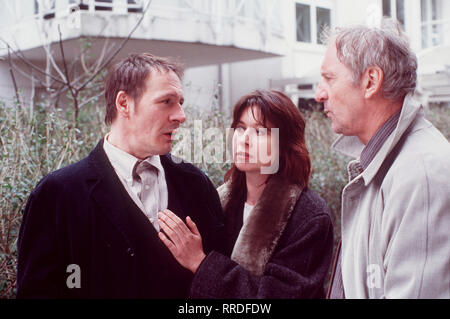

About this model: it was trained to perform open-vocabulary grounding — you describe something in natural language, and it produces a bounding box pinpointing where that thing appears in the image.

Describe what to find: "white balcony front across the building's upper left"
[0,0,286,55]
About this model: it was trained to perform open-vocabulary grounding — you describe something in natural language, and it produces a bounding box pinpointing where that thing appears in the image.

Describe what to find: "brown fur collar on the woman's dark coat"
[218,176,302,276]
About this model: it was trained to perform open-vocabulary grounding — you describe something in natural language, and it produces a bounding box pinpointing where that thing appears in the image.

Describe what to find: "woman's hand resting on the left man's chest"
[158,209,206,273]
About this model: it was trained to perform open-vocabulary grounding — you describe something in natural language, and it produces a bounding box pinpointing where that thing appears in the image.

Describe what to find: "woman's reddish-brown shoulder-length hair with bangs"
[225,90,311,190]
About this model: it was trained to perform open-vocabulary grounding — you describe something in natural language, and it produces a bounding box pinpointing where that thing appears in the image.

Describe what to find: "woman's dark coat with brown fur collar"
[190,176,333,298]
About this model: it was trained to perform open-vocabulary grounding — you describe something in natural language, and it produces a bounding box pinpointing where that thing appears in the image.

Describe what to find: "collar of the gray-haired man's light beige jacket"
[331,94,423,186]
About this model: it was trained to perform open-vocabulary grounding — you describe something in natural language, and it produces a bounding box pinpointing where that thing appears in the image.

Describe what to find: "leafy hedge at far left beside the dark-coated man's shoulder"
[0,104,106,298]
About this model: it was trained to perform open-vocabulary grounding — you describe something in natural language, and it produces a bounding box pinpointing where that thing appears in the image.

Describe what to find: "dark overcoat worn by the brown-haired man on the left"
[17,139,223,298]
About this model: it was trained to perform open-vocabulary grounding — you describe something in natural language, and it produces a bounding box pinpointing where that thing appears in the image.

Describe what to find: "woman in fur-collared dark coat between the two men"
[159,91,333,298]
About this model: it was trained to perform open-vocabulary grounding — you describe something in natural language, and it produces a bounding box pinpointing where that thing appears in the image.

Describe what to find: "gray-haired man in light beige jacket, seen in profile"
[316,21,450,298]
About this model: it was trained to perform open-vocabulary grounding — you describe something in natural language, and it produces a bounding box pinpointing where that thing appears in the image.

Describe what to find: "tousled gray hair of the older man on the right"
[322,19,417,101]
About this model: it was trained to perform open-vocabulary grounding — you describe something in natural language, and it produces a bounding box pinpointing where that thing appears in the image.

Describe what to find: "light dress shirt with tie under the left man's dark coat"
[103,135,169,231]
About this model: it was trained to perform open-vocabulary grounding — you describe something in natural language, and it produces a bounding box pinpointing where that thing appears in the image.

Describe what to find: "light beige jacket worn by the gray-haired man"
[333,96,450,298]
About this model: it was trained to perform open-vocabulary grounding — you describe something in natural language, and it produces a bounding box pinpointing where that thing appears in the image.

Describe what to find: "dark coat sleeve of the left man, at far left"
[17,178,65,298]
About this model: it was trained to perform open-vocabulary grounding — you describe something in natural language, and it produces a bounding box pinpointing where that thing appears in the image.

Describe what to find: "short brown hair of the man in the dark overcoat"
[105,53,183,125]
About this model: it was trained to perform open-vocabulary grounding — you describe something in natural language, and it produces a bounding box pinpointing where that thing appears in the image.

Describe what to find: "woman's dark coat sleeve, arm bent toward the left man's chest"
[190,195,333,298]
